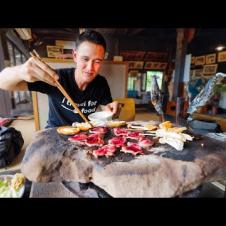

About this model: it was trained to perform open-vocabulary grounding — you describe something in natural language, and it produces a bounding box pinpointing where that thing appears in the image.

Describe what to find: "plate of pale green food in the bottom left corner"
[0,173,25,198]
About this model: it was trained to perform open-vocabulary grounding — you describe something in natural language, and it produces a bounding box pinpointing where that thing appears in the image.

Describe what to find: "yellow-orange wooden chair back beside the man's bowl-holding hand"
[114,98,136,121]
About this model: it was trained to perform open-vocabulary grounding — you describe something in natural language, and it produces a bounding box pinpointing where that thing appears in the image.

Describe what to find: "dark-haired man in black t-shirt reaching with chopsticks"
[0,30,118,128]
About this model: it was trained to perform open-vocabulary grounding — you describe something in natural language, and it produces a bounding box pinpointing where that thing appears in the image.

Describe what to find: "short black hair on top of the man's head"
[76,29,107,51]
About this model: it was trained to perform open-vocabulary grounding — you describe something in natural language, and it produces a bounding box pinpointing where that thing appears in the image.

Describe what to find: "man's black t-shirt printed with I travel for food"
[28,68,112,128]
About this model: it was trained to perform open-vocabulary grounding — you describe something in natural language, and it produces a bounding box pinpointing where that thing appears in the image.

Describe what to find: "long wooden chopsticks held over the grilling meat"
[30,50,93,128]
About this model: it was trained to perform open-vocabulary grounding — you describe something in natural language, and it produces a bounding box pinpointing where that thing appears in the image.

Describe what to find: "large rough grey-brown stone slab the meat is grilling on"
[21,126,226,197]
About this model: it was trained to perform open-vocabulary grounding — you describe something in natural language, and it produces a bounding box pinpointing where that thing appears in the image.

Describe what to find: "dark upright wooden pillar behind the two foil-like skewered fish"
[173,28,187,101]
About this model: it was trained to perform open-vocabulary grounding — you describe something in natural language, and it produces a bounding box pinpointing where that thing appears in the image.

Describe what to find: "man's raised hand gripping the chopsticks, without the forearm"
[19,57,59,86]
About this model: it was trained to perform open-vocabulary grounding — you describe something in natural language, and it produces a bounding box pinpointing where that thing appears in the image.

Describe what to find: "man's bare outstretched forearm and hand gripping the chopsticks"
[0,57,58,91]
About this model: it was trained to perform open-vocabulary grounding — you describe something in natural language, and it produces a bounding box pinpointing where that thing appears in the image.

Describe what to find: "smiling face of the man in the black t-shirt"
[73,41,105,82]
